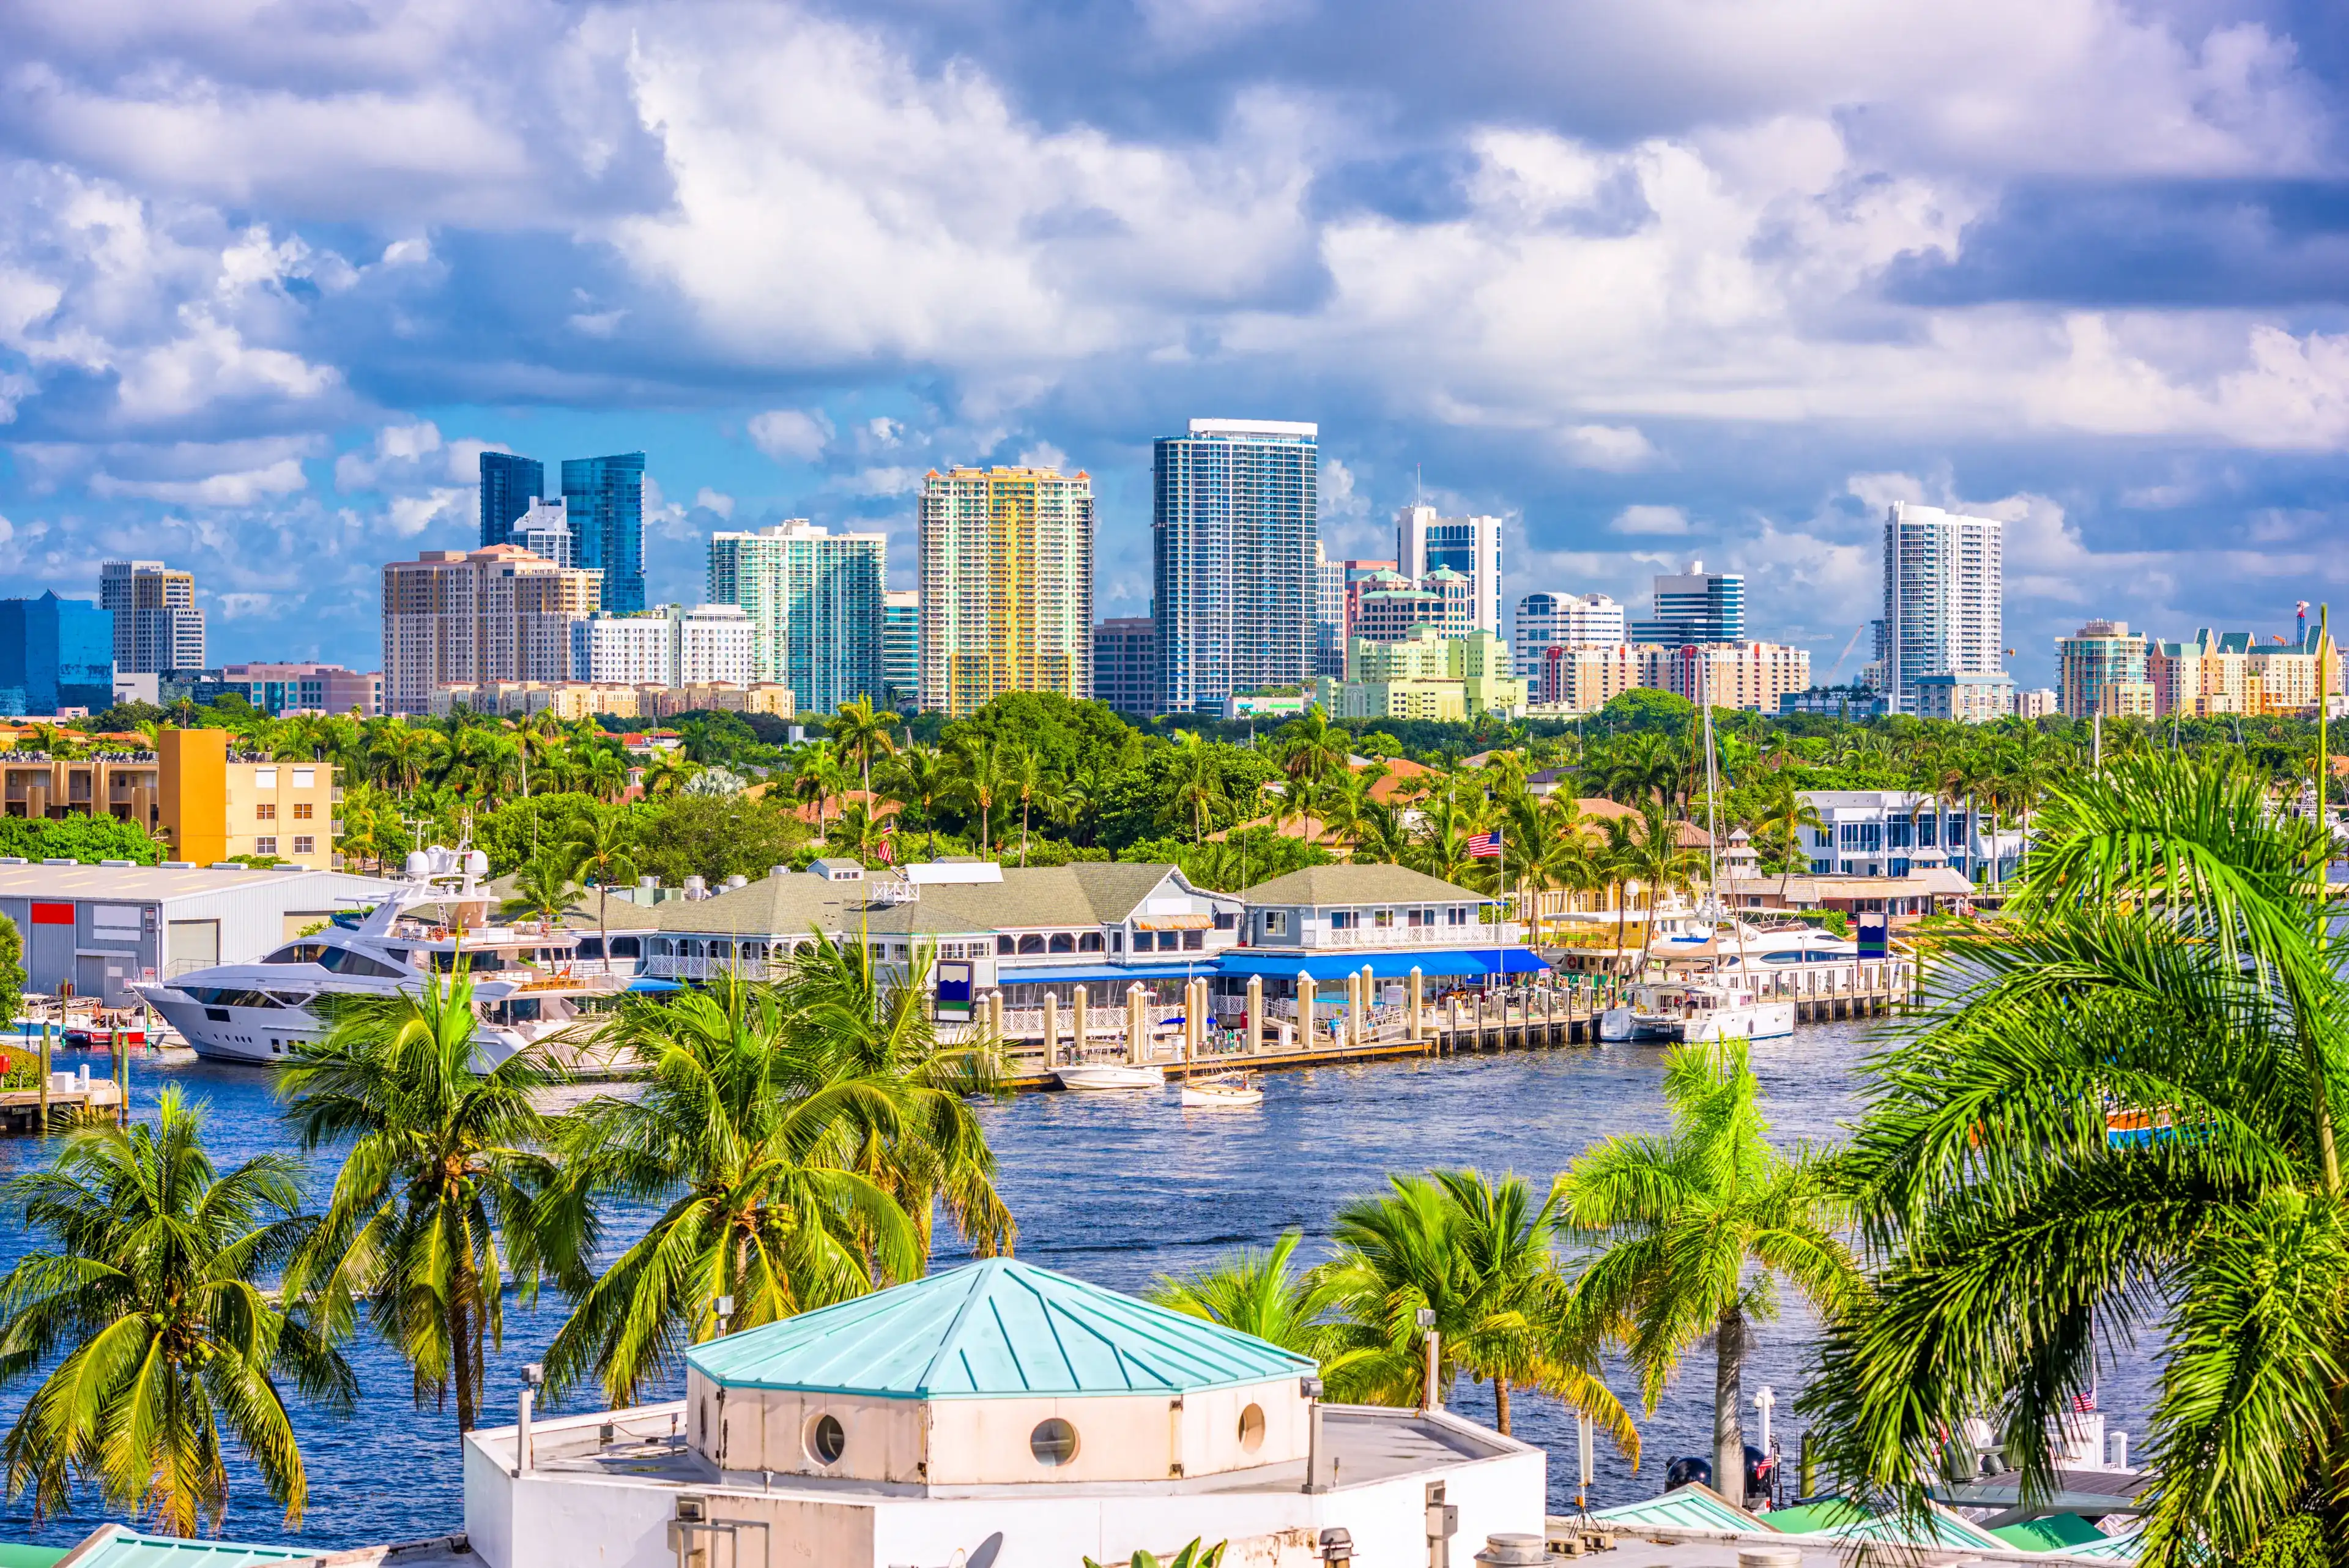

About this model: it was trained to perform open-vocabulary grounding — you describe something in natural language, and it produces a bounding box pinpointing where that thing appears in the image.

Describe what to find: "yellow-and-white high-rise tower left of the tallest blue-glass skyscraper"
[918,468,1094,717]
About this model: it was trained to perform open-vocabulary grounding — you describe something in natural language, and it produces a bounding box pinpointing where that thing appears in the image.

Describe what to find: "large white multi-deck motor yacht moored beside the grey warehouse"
[136,846,629,1072]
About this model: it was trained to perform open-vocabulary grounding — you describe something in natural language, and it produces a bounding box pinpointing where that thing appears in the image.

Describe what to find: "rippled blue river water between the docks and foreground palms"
[0,1025,2150,1549]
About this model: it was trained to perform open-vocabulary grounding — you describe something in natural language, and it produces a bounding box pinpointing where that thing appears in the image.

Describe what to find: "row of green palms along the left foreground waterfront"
[0,943,1015,1533]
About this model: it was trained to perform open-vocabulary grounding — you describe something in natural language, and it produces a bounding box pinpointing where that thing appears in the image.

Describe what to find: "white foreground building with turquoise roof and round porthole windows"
[465,1258,1546,1568]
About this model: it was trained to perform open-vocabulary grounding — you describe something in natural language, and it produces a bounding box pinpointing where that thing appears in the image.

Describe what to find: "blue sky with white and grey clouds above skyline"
[0,0,2349,686]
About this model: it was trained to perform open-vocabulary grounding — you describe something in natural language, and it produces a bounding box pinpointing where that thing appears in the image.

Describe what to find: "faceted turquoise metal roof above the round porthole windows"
[686,1258,1315,1399]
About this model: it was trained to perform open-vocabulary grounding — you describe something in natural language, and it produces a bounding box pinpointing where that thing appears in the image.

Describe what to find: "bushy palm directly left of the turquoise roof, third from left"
[547,976,954,1406]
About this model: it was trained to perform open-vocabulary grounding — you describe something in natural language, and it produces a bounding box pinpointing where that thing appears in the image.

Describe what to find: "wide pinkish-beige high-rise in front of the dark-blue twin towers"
[383,545,599,715]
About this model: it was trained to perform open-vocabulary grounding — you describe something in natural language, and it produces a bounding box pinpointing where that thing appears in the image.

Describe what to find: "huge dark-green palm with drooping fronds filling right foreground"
[1806,754,2349,1568]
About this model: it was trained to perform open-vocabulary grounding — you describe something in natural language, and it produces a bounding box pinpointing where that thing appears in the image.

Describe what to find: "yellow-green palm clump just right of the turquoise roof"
[1320,1171,1639,1462]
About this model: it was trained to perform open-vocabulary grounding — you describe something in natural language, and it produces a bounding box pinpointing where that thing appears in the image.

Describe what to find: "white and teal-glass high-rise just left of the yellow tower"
[707,517,888,715]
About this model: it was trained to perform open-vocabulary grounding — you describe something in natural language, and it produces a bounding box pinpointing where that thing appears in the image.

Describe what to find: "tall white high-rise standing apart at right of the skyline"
[1874,500,2006,712]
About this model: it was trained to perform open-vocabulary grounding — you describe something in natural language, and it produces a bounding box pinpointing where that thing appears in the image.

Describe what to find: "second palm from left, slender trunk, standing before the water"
[277,971,563,1432]
